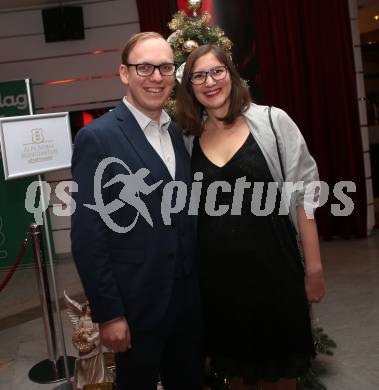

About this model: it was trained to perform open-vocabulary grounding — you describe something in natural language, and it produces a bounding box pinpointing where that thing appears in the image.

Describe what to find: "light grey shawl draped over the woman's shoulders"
[185,103,319,231]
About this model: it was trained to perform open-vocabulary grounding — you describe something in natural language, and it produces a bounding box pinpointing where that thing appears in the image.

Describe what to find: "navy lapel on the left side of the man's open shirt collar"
[113,102,172,182]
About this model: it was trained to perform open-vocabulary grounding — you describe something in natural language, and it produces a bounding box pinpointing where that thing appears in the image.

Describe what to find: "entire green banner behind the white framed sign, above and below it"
[0,80,37,269]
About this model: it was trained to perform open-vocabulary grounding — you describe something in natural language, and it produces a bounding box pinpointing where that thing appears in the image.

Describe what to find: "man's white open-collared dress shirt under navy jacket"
[124,96,175,179]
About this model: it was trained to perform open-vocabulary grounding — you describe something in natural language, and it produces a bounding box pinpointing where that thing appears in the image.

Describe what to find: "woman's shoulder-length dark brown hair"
[176,45,251,135]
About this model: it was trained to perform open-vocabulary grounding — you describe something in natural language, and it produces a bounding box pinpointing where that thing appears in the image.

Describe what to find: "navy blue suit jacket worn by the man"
[71,102,197,330]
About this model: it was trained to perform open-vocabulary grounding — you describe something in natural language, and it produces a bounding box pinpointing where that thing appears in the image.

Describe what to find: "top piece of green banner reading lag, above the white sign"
[0,80,30,117]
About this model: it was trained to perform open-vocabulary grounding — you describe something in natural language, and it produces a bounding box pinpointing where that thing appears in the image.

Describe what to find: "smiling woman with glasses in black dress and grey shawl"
[177,45,325,390]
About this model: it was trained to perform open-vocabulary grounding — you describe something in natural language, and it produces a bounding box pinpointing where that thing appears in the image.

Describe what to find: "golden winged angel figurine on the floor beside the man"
[63,291,112,390]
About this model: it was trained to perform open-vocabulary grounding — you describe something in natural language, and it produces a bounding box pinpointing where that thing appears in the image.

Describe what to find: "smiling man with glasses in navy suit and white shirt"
[71,32,202,390]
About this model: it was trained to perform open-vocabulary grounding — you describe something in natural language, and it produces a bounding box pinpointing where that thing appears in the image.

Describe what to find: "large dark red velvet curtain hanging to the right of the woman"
[255,0,367,239]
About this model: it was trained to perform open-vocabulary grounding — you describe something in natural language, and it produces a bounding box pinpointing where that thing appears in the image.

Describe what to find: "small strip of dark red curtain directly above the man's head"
[137,0,178,38]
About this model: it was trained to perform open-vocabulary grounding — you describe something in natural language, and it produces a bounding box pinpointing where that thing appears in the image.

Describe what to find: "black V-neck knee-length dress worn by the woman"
[192,134,315,384]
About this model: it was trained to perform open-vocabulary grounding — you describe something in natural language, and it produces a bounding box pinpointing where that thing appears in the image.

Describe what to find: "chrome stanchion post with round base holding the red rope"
[29,223,75,389]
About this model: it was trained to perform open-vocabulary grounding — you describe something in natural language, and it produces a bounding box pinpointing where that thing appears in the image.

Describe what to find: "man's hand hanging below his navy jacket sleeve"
[99,317,132,352]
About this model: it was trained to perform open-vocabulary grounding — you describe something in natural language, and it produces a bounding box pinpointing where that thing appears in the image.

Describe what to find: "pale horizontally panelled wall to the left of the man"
[0,0,139,255]
